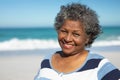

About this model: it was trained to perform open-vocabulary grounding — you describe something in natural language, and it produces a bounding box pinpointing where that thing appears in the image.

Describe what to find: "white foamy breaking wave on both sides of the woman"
[0,38,120,51]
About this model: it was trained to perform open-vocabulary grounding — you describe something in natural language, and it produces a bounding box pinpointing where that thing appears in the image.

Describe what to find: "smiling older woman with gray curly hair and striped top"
[35,3,120,80]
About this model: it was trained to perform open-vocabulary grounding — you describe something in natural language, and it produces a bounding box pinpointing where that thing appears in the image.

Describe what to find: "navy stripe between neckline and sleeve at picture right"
[78,59,102,72]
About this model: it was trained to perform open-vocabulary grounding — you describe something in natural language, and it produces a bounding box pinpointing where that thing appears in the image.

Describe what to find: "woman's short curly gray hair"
[54,3,102,47]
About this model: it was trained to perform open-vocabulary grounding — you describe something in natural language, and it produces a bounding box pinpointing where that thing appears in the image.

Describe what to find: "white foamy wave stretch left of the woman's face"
[0,38,59,51]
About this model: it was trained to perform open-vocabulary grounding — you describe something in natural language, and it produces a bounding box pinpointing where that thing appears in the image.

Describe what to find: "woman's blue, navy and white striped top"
[34,53,120,80]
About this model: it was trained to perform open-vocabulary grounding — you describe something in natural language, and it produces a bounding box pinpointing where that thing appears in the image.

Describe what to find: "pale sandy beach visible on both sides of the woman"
[0,50,120,80]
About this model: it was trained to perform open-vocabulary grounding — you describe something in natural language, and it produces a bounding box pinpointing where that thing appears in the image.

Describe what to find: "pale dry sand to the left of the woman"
[0,56,42,80]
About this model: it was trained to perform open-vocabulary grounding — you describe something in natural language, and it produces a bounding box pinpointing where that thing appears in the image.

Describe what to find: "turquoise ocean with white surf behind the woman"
[0,26,120,51]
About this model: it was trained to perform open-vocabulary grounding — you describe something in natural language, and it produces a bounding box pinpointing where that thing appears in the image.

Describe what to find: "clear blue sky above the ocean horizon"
[0,0,120,27]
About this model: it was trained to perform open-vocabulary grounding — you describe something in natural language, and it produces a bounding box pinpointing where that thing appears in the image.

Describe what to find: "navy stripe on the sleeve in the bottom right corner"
[101,69,120,80]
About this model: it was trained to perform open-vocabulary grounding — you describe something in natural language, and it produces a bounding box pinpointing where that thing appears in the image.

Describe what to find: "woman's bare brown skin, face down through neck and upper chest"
[52,20,89,73]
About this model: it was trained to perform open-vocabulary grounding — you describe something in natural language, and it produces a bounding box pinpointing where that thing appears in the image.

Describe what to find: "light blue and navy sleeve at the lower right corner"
[98,58,120,80]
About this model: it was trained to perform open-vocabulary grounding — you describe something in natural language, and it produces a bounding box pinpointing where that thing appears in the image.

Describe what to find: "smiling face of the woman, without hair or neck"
[58,20,88,55]
